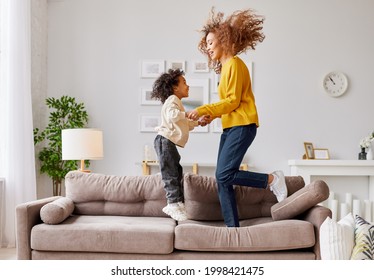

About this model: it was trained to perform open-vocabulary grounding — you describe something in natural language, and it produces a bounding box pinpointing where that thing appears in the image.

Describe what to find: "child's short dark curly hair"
[151,69,184,104]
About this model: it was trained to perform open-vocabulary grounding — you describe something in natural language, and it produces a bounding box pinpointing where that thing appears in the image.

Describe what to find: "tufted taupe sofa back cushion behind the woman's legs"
[184,173,305,221]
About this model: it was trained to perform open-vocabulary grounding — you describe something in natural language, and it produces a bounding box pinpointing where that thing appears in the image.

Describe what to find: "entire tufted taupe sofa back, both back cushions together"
[65,171,305,221]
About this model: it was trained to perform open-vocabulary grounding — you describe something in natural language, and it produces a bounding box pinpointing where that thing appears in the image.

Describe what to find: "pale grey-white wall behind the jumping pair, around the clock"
[35,0,374,197]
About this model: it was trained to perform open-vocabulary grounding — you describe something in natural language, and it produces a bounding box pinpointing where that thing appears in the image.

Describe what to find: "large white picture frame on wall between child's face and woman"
[182,77,209,132]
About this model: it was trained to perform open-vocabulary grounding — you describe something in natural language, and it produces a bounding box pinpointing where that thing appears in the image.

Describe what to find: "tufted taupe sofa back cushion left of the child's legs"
[65,171,166,217]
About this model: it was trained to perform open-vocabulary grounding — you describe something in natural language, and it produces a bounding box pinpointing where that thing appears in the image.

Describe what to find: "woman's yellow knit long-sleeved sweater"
[196,56,259,129]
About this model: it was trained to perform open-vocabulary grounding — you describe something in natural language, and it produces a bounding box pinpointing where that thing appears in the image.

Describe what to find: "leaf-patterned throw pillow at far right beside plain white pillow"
[351,215,374,260]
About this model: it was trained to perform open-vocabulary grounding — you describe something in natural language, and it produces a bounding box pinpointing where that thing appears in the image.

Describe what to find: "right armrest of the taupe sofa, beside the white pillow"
[299,205,332,260]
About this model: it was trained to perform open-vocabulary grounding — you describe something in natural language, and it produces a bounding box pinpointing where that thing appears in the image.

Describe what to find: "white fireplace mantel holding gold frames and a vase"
[288,159,374,201]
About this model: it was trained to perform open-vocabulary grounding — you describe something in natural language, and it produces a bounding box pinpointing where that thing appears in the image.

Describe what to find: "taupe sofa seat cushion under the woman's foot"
[175,217,315,252]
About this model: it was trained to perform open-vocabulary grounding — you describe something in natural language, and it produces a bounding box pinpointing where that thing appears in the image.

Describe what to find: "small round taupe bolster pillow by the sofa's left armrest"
[40,197,74,225]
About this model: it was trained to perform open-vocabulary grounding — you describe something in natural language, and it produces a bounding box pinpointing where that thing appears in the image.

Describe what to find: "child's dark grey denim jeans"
[154,135,184,203]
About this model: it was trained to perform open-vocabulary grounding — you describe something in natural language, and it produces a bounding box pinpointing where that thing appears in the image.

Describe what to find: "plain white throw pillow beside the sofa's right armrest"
[319,213,355,260]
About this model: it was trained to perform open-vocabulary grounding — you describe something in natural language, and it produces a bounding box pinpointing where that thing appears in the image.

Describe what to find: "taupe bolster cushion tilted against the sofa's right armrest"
[271,180,329,220]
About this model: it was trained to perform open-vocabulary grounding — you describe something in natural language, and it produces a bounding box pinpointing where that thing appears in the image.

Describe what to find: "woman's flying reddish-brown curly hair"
[198,7,265,73]
